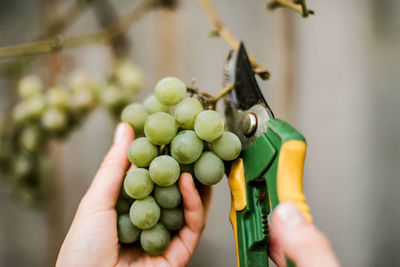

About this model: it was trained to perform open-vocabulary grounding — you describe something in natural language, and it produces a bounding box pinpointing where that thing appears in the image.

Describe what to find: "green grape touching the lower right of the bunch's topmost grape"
[175,98,204,130]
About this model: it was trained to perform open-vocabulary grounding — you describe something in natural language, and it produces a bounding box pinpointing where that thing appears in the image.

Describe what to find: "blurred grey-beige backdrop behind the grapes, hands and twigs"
[0,0,400,267]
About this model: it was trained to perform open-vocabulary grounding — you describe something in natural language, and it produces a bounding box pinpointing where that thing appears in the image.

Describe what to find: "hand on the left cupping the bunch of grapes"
[56,124,211,267]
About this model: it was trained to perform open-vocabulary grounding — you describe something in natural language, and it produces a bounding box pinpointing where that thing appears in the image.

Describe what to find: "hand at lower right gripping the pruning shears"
[269,202,339,267]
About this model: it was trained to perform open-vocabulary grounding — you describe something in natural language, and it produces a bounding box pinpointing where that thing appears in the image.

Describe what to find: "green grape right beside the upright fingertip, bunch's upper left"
[121,104,149,134]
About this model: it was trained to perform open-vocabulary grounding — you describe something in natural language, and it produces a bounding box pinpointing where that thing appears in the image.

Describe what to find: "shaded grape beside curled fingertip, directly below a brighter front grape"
[154,183,182,209]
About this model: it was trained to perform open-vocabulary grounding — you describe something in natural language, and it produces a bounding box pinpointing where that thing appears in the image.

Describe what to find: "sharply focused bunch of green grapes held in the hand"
[116,77,242,255]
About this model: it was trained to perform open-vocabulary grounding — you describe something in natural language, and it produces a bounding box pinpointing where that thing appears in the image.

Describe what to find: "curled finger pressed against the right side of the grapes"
[164,173,206,266]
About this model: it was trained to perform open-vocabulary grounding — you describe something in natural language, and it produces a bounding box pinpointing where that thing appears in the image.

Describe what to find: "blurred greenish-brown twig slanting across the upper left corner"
[0,0,160,58]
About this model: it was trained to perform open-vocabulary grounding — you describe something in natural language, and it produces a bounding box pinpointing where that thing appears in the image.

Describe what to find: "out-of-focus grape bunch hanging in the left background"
[0,60,144,206]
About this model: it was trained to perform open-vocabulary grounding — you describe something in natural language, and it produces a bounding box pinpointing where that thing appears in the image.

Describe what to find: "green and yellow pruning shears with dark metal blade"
[224,44,311,267]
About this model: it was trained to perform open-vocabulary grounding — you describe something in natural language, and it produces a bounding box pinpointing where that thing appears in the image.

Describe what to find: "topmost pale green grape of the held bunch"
[155,77,186,106]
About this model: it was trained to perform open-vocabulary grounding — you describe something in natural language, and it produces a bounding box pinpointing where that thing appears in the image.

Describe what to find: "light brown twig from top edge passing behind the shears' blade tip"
[198,0,270,80]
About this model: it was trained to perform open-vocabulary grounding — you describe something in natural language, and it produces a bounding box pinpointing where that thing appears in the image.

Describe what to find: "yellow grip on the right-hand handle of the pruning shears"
[277,140,312,222]
